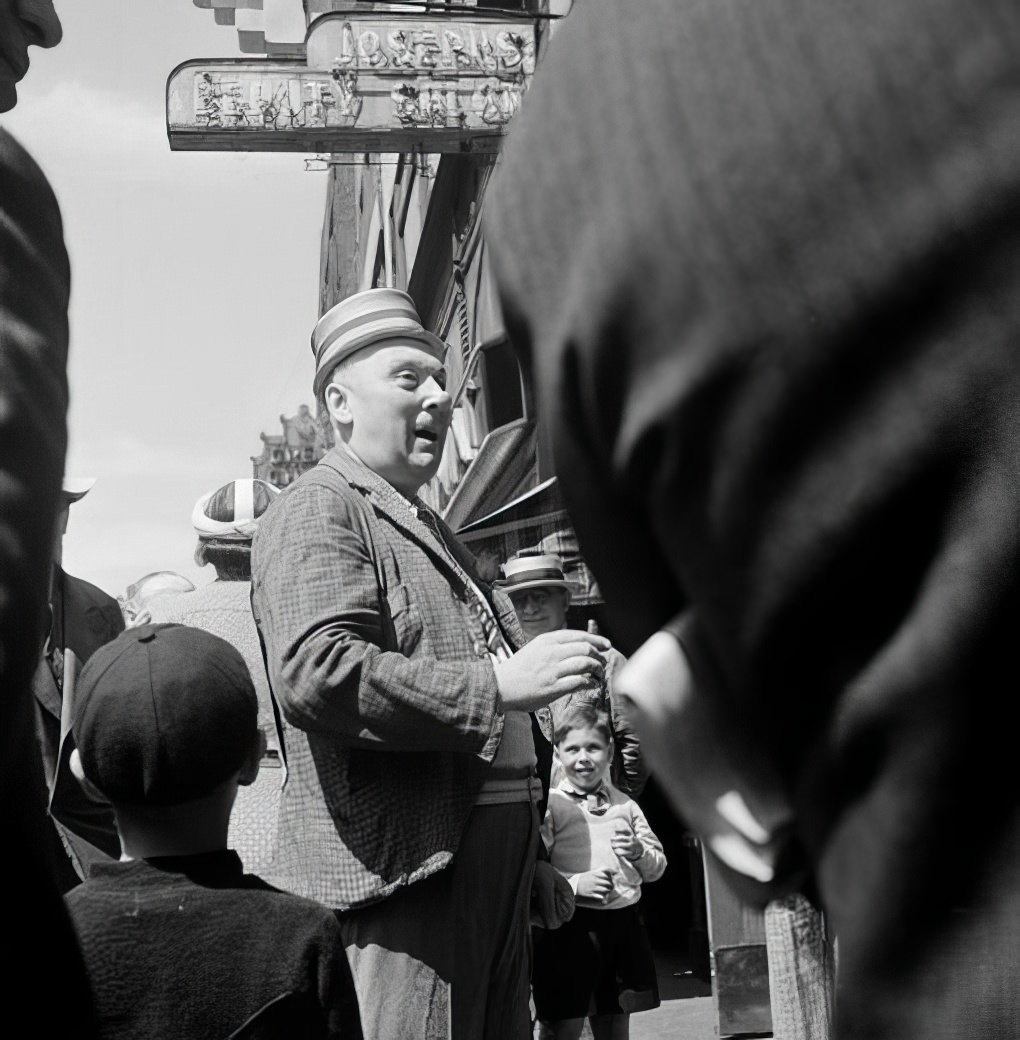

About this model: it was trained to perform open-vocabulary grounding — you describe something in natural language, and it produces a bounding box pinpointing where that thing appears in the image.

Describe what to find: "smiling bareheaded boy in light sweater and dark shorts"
[532,702,665,1040]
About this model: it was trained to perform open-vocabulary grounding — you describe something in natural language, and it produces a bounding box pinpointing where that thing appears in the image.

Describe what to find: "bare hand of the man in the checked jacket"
[495,628,609,711]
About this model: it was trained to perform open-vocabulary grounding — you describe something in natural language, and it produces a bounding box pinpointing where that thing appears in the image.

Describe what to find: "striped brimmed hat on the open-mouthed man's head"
[312,288,446,396]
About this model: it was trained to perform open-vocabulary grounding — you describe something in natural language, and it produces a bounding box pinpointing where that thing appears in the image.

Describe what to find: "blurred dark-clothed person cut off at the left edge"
[0,0,97,1037]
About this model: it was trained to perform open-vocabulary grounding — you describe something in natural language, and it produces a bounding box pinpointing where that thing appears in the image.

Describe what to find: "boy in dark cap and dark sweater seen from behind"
[66,624,349,1040]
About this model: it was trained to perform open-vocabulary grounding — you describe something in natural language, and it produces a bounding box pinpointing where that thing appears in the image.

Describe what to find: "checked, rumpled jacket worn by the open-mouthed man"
[252,447,541,909]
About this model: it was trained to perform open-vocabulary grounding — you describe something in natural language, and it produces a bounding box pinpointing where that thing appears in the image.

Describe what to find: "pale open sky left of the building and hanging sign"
[0,0,325,595]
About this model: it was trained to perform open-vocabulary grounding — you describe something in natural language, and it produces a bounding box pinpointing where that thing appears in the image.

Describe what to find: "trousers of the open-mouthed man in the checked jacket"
[339,802,539,1040]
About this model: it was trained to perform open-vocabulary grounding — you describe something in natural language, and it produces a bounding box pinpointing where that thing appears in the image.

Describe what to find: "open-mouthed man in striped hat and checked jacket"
[252,288,608,1040]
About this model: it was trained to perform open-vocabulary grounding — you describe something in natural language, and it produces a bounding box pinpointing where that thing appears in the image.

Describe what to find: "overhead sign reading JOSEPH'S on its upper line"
[166,15,535,153]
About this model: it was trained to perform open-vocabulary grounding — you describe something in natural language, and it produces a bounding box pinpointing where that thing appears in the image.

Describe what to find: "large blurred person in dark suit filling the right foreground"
[487,0,1020,1040]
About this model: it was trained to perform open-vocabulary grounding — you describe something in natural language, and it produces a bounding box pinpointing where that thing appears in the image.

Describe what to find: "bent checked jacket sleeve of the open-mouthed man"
[252,483,502,761]
